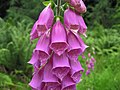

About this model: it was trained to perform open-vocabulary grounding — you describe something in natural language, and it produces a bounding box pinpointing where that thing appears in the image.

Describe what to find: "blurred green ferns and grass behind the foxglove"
[0,0,120,90]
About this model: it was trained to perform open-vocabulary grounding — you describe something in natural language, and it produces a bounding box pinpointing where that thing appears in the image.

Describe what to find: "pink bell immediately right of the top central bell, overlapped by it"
[68,32,82,60]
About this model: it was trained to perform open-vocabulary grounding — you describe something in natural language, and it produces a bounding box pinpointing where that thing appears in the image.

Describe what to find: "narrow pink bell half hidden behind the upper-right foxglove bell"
[77,15,87,37]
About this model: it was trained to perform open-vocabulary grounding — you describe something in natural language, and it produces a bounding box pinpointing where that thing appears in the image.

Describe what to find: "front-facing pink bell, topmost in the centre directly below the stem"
[50,20,68,55]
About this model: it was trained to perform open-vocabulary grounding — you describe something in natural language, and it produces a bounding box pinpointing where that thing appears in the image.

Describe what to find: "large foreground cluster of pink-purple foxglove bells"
[28,0,88,90]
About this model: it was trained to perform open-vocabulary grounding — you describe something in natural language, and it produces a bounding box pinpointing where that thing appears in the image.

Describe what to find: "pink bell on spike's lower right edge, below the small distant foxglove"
[70,60,84,83]
